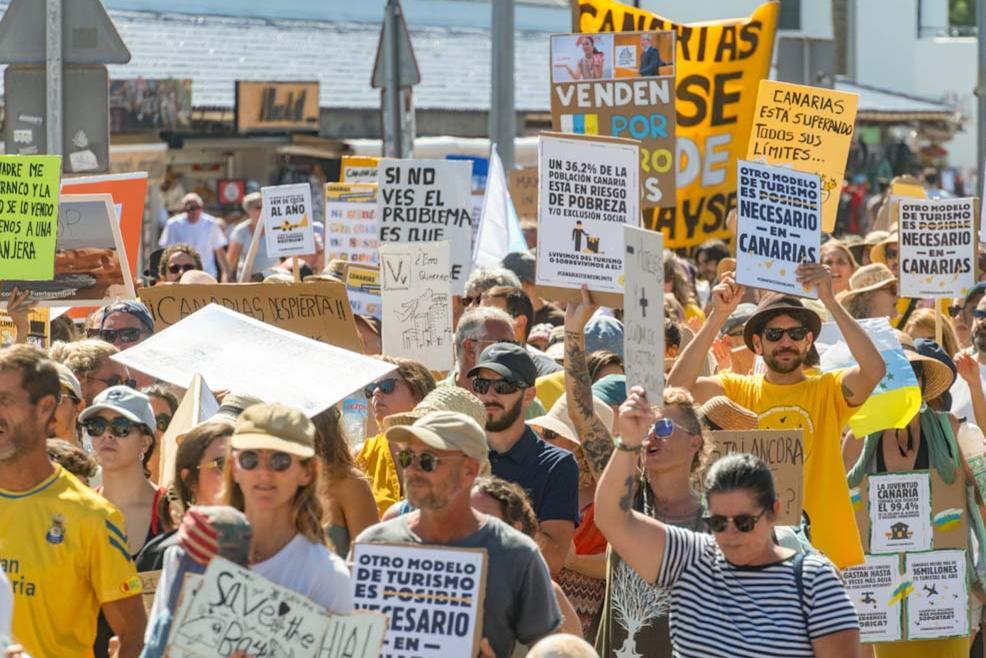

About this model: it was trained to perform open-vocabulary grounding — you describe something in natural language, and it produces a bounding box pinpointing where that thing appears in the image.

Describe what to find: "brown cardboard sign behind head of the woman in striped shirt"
[708,429,805,525]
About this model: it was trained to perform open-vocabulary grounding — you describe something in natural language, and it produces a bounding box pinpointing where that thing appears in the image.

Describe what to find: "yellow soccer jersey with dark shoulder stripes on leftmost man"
[0,466,140,658]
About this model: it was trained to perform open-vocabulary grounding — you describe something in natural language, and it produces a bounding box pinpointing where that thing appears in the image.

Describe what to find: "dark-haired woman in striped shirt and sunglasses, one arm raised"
[596,387,859,658]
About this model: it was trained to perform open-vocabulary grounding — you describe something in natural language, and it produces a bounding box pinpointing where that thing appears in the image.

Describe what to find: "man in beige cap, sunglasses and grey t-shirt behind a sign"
[356,411,561,658]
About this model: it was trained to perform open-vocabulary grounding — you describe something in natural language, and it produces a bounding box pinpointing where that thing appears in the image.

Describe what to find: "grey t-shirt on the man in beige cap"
[356,515,561,658]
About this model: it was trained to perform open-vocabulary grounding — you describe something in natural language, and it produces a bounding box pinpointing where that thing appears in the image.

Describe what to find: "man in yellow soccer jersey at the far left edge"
[0,345,146,658]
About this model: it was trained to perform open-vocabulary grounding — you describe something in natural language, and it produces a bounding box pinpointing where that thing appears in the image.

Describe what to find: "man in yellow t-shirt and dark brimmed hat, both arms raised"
[668,263,886,569]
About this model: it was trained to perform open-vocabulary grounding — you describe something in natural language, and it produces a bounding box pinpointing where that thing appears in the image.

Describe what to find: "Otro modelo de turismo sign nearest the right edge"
[898,199,976,299]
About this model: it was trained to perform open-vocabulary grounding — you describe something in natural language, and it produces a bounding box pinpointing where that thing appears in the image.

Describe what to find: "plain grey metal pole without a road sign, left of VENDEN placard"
[490,0,517,171]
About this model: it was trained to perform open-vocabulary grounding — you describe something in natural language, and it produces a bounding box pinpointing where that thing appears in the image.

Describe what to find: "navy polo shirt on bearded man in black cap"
[490,425,579,525]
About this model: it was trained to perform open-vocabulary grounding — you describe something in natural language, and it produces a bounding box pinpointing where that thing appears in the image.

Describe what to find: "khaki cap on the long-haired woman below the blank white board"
[230,404,315,459]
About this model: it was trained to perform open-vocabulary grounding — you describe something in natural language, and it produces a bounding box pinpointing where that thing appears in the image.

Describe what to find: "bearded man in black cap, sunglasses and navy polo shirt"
[468,343,579,573]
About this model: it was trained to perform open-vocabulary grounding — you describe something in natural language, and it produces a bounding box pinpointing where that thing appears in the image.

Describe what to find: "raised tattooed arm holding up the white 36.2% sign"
[565,285,613,482]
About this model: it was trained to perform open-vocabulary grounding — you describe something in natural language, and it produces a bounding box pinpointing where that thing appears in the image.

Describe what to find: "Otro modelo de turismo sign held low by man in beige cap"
[352,544,487,658]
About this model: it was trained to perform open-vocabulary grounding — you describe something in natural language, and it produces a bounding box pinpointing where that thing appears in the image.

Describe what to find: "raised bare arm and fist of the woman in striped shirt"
[595,386,665,583]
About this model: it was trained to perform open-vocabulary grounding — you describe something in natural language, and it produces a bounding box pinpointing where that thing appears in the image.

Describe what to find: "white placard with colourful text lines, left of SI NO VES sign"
[325,183,380,265]
